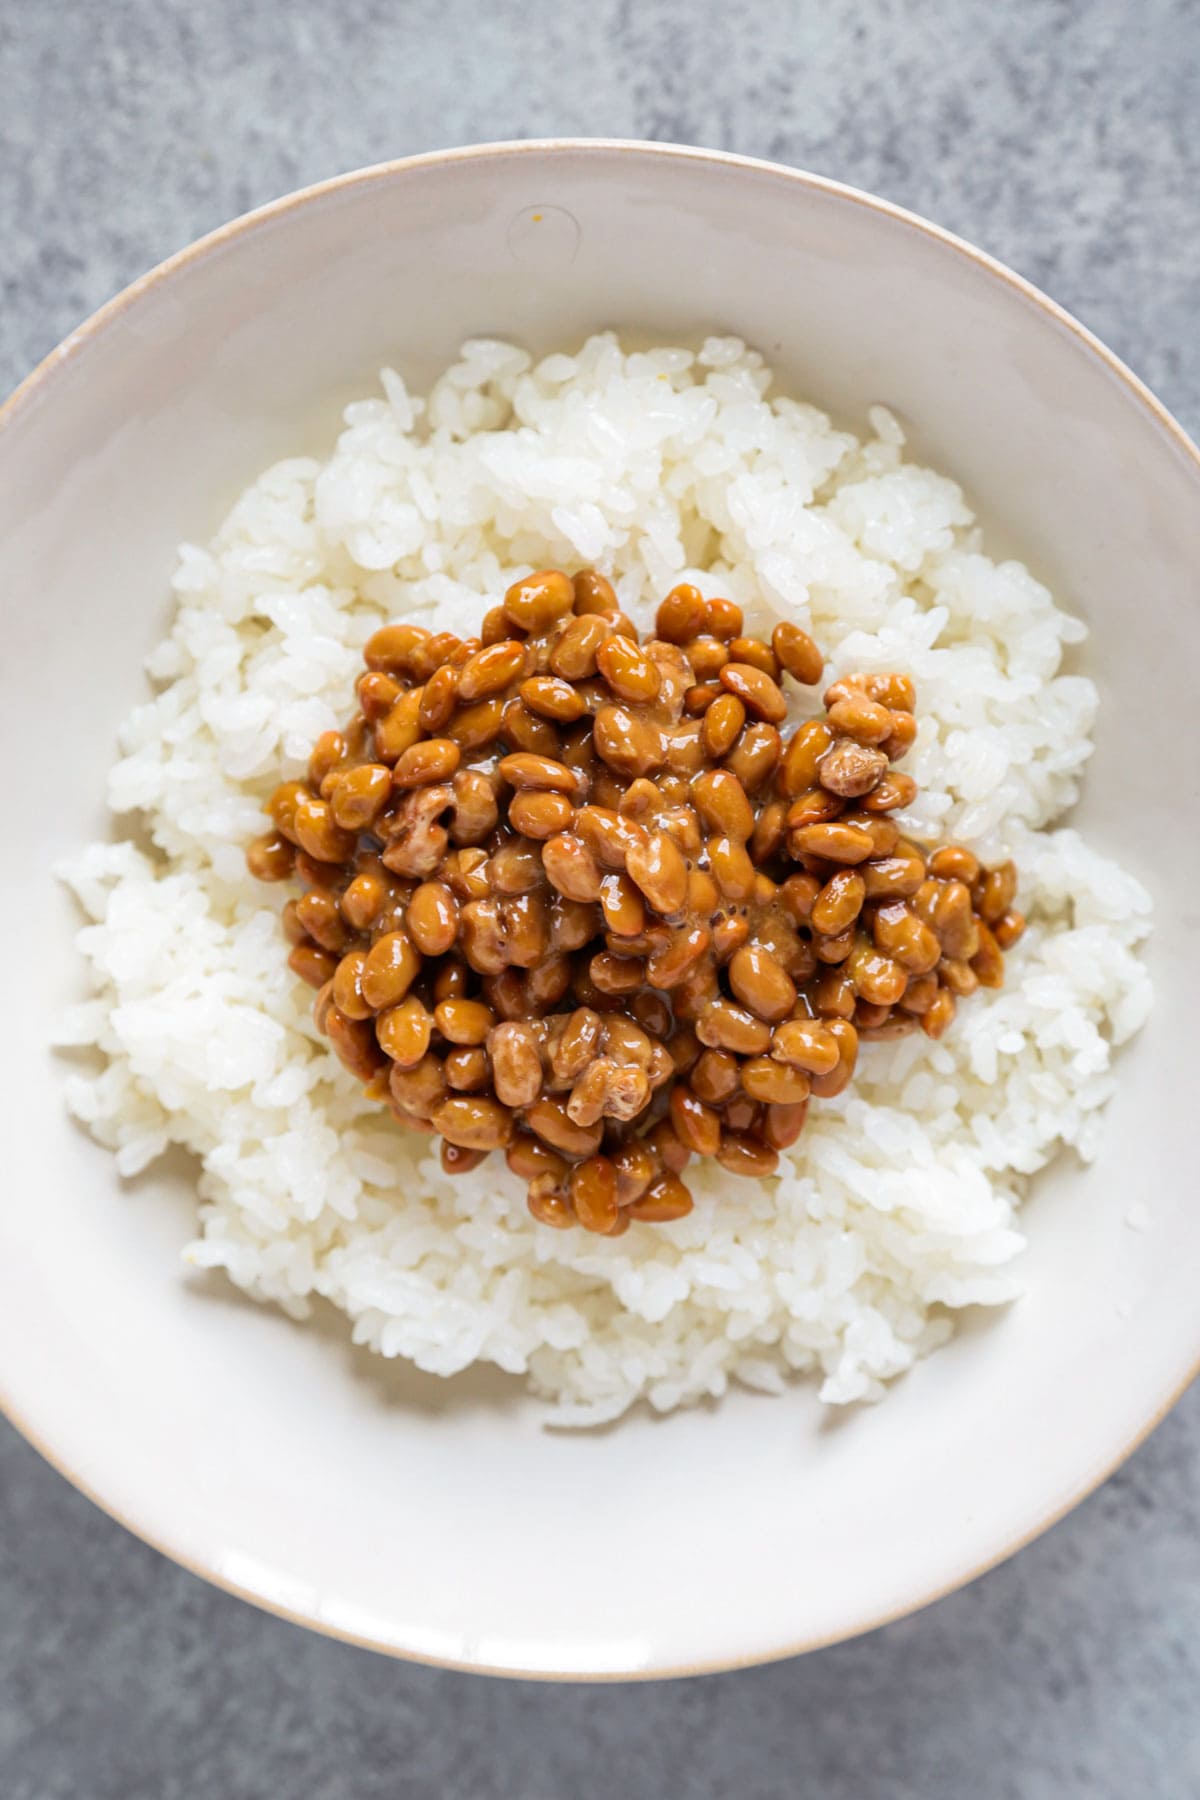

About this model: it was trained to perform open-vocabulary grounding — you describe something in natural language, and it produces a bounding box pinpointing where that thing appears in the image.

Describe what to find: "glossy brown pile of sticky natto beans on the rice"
[246,569,1024,1237]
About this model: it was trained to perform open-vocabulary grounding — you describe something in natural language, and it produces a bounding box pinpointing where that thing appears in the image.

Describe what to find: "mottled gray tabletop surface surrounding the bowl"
[0,0,1200,1800]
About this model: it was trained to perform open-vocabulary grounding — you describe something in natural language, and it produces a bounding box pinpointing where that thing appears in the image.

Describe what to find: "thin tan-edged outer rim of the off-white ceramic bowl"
[0,137,1200,1685]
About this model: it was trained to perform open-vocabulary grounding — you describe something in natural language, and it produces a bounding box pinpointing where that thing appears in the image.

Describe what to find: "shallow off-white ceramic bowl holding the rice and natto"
[0,142,1200,1676]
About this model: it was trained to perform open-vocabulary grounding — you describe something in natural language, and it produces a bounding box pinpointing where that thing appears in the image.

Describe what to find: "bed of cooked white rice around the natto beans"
[63,335,1151,1422]
